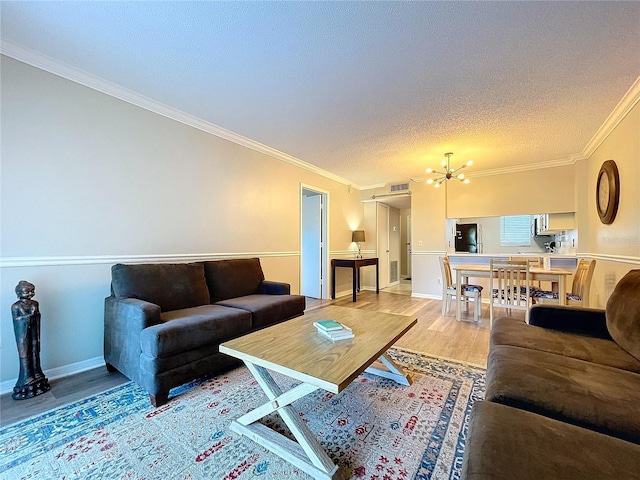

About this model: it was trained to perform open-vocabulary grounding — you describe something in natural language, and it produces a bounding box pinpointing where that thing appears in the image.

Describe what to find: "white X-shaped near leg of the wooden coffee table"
[231,361,343,480]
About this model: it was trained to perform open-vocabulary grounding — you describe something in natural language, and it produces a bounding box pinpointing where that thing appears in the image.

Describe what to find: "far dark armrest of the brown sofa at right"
[529,305,611,340]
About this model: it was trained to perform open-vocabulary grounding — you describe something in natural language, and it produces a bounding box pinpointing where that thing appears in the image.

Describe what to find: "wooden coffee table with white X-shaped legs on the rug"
[220,306,417,480]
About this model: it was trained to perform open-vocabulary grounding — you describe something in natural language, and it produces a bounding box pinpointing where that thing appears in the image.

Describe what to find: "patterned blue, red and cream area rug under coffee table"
[0,348,485,480]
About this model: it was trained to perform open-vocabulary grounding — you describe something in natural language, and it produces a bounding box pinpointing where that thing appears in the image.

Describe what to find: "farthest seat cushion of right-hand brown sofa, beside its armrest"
[490,318,640,373]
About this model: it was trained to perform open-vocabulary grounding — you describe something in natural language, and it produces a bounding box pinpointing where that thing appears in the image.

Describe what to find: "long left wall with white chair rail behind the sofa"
[0,56,363,388]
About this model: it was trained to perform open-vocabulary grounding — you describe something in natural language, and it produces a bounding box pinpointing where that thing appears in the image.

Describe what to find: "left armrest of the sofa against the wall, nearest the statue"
[104,296,161,382]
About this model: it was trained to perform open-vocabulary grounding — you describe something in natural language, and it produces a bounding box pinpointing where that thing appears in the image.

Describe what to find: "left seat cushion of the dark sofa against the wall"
[140,305,251,357]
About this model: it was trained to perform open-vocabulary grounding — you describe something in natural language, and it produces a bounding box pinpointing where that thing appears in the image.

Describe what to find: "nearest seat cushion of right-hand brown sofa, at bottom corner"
[460,402,640,480]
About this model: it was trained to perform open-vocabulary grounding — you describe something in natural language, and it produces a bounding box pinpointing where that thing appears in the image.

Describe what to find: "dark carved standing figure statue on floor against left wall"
[11,280,51,400]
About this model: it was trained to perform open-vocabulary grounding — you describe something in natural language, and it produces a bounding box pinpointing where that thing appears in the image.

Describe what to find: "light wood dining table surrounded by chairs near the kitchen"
[451,264,573,321]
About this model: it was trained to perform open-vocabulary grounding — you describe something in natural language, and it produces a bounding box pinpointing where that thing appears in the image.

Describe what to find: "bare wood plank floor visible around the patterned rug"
[0,289,510,426]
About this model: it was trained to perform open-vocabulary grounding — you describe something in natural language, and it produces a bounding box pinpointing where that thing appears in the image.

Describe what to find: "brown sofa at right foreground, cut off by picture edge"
[461,270,640,480]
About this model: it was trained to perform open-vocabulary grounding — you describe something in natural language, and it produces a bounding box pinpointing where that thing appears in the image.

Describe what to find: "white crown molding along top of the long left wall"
[0,40,362,190]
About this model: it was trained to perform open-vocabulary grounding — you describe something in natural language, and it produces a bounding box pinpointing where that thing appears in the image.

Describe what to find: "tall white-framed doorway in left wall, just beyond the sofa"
[300,185,328,299]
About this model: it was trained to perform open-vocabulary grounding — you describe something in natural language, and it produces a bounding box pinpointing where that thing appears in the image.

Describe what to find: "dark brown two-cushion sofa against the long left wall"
[104,258,305,406]
